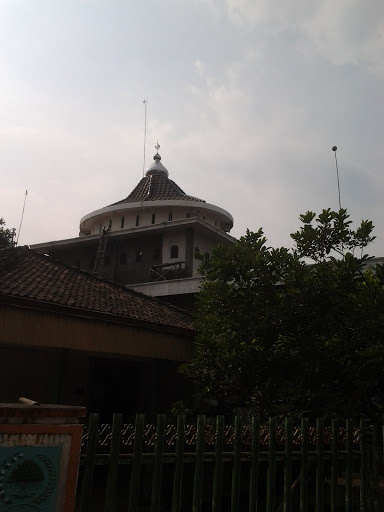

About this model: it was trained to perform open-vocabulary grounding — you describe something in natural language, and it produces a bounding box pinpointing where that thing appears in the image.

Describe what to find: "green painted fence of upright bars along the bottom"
[77,414,384,512]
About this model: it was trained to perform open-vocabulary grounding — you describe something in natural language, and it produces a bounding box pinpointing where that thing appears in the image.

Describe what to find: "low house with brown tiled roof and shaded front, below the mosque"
[0,247,194,420]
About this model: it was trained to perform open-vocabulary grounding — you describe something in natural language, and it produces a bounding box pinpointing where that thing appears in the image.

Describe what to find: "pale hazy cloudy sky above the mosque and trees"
[0,0,384,256]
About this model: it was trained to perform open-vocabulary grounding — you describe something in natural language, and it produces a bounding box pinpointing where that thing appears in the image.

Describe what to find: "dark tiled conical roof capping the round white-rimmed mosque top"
[111,173,205,206]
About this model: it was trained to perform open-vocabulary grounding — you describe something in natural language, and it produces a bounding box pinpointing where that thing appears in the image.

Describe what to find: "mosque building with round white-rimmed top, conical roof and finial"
[31,144,234,309]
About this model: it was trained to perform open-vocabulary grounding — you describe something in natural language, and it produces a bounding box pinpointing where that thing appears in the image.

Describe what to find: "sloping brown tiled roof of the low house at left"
[0,247,193,335]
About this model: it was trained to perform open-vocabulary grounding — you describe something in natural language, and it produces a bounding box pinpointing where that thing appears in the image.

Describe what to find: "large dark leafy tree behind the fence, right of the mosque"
[182,209,384,417]
